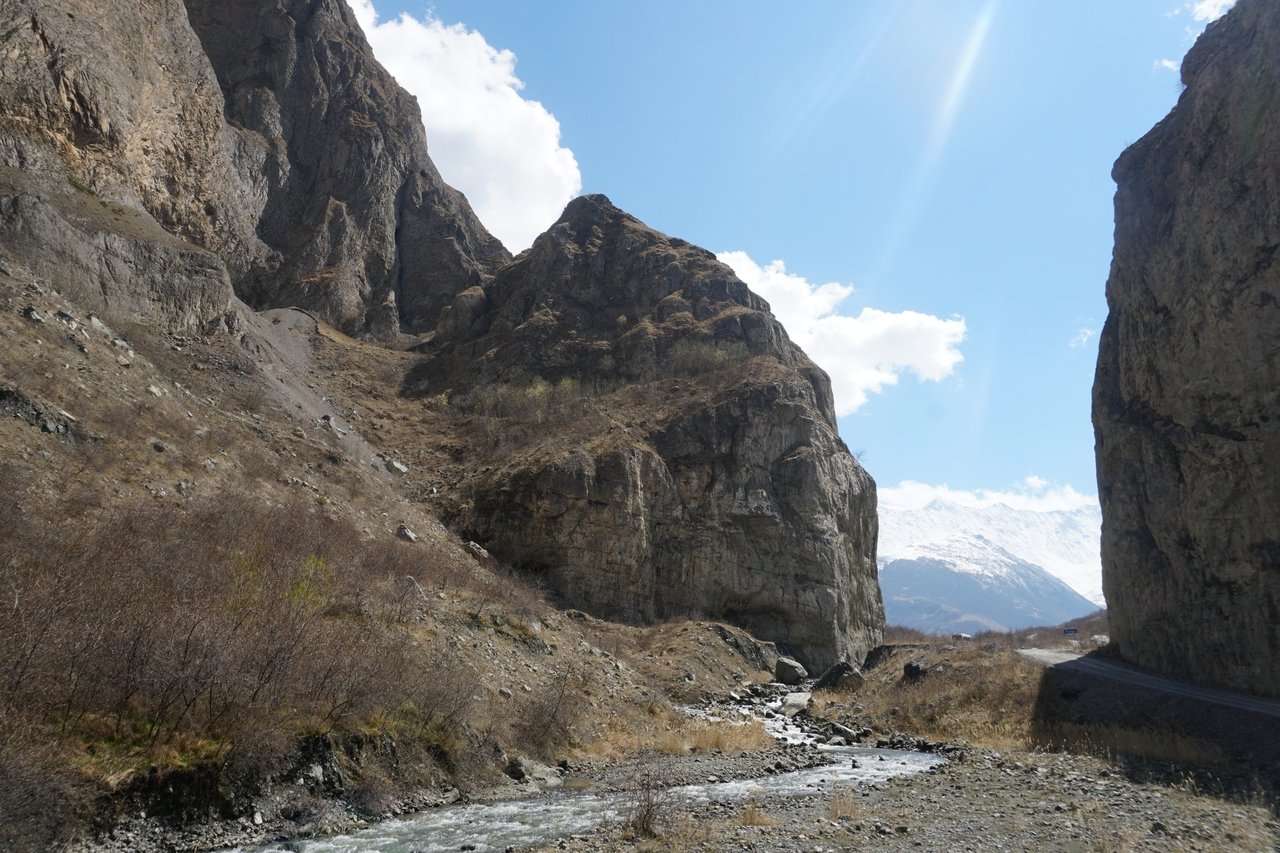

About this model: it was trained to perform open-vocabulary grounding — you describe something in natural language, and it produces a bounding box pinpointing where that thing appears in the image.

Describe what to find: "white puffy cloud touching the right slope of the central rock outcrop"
[717,252,965,415]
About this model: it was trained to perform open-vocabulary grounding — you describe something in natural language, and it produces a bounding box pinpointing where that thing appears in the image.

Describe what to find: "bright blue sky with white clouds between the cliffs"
[348,0,1233,508]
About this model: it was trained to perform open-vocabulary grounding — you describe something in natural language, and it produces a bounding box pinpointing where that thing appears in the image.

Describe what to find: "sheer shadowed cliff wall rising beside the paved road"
[1093,0,1280,695]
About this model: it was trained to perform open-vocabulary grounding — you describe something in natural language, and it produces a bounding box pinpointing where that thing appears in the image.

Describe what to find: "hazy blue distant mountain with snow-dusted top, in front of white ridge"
[879,534,1098,634]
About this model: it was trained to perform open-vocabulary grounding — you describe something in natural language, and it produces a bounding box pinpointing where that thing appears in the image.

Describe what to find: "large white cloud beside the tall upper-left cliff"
[348,0,582,251]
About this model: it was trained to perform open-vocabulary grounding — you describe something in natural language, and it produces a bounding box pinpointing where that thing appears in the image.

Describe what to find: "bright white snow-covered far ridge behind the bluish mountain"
[878,500,1103,607]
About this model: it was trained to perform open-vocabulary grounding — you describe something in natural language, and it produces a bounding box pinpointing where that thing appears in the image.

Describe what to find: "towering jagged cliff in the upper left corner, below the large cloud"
[0,0,509,336]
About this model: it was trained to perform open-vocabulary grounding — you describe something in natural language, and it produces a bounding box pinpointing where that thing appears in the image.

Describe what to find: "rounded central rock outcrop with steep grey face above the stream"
[416,196,883,667]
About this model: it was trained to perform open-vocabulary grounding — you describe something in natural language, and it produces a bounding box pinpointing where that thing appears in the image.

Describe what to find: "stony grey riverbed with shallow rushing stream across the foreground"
[74,685,1280,853]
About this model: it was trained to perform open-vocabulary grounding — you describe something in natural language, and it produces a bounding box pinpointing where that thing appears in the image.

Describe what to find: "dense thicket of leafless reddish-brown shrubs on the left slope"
[0,492,467,794]
